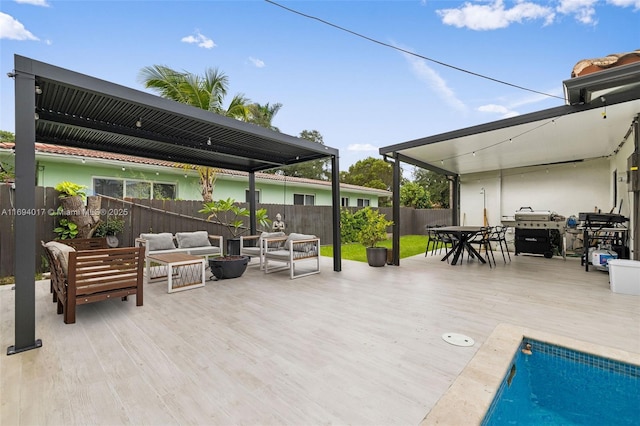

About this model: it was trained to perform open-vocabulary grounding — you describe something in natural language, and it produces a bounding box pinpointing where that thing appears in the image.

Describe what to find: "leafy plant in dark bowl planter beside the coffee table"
[198,198,271,279]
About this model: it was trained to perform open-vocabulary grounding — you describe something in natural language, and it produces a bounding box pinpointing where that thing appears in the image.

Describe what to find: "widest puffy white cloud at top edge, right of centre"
[436,0,555,31]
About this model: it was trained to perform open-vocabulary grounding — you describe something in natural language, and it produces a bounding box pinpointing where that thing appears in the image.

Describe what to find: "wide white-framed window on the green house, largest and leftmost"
[93,178,176,200]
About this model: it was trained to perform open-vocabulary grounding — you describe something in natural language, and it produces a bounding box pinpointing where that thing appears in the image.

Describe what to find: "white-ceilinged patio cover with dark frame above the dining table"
[379,62,640,265]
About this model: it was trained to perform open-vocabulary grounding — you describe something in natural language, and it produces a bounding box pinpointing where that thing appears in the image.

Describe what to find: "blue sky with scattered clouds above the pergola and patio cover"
[0,0,640,174]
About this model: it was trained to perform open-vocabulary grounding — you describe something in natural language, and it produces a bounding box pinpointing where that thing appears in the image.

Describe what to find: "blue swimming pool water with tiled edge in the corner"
[482,338,640,426]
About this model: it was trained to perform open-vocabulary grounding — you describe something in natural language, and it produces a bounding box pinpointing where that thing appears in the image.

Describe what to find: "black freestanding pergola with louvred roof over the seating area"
[8,55,341,355]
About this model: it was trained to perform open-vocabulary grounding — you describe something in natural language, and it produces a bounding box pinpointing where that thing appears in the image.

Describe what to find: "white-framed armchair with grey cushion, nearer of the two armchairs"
[262,233,320,279]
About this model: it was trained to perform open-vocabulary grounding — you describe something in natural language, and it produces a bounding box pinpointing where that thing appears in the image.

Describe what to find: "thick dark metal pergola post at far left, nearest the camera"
[7,57,42,355]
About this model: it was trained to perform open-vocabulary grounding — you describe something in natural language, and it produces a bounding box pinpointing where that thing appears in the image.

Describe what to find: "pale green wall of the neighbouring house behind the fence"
[37,157,378,207]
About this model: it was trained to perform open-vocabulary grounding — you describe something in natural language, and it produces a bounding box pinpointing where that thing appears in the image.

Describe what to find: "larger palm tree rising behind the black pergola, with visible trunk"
[138,65,252,202]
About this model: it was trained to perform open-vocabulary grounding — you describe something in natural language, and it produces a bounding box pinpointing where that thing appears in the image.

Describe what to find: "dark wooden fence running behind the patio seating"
[0,184,451,277]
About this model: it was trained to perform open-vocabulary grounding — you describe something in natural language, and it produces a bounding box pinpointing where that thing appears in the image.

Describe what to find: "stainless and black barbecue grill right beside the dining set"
[504,207,567,259]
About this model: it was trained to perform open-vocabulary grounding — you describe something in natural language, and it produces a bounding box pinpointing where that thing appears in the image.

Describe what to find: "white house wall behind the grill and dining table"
[460,158,614,225]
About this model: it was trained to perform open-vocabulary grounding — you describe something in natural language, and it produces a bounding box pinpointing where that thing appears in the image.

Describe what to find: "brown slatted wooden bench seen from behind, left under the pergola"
[41,241,144,324]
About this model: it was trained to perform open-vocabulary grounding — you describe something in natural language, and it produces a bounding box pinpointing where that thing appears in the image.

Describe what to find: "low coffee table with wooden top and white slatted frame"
[146,253,206,293]
